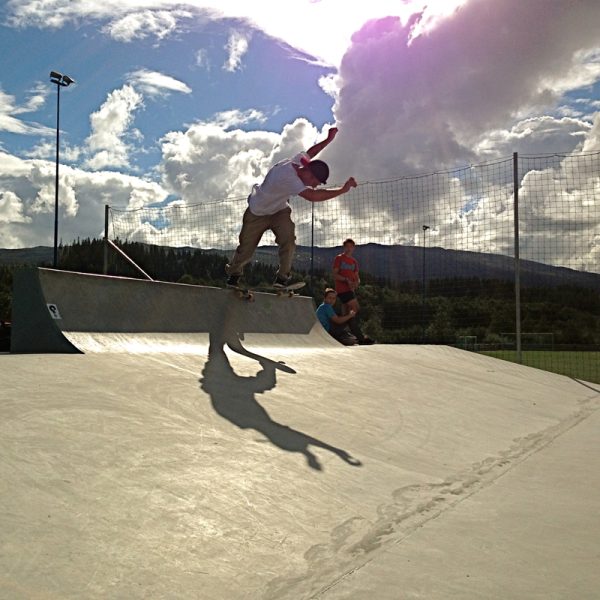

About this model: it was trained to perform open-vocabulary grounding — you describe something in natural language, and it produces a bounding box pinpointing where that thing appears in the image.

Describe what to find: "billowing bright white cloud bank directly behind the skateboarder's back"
[107,114,322,248]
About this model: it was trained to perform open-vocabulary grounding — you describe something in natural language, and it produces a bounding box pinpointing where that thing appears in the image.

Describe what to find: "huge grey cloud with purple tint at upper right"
[332,0,600,178]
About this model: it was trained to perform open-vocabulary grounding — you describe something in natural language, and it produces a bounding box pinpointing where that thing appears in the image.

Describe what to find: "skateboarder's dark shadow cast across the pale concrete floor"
[200,332,362,471]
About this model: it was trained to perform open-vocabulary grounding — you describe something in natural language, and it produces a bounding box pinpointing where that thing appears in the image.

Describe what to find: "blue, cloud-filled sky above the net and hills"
[0,0,600,255]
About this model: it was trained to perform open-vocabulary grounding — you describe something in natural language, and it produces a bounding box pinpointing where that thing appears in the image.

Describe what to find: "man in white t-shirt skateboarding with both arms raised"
[225,127,356,287]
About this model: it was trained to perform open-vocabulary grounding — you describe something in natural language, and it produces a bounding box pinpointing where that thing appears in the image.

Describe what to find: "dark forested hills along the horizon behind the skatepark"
[0,240,600,349]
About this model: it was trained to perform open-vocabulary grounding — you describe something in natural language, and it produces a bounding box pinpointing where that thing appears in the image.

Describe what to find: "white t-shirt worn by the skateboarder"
[248,152,310,216]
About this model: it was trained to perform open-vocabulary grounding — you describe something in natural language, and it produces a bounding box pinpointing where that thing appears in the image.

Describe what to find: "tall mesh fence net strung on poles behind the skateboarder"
[109,152,600,381]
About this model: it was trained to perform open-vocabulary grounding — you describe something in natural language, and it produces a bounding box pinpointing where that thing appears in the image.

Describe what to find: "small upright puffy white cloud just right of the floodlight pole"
[86,85,143,170]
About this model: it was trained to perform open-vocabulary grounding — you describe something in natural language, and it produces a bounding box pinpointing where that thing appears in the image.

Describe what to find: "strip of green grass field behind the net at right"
[481,350,600,383]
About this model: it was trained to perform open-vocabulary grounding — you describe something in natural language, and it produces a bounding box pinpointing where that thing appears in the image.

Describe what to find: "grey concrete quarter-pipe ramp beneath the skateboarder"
[11,269,337,353]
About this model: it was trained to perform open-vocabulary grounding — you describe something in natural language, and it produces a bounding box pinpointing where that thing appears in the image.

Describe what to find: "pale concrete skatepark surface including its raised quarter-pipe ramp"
[0,269,600,600]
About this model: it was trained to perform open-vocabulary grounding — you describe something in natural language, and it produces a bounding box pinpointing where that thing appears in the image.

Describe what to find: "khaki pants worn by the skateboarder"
[225,208,296,277]
